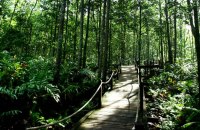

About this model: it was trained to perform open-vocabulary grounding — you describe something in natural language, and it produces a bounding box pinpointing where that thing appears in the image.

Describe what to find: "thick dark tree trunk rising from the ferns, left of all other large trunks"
[54,0,66,84]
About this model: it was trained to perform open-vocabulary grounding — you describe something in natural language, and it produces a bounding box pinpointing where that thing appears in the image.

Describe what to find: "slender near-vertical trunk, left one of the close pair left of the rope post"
[78,0,84,69]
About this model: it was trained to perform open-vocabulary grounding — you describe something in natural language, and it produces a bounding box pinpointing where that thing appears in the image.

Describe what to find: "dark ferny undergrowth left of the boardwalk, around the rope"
[0,51,98,130]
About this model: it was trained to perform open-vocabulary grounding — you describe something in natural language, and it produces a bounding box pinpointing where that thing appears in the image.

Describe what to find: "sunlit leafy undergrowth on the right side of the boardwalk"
[146,62,200,130]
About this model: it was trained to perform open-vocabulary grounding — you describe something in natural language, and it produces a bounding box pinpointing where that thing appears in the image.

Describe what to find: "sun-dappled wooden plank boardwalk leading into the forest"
[78,66,138,130]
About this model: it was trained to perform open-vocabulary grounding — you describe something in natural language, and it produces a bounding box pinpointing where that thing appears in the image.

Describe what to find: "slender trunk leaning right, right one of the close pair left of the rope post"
[83,0,91,68]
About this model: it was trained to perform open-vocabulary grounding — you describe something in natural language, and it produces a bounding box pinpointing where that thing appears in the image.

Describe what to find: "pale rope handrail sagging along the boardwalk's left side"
[26,72,118,130]
